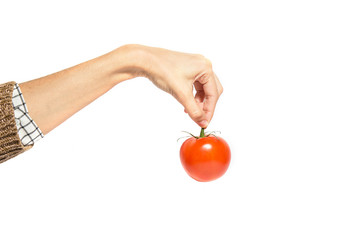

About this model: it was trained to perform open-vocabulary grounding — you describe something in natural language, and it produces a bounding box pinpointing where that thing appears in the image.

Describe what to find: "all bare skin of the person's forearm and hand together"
[20,44,223,134]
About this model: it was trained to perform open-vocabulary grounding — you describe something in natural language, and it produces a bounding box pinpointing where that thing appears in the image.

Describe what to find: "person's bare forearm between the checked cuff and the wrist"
[20,46,142,134]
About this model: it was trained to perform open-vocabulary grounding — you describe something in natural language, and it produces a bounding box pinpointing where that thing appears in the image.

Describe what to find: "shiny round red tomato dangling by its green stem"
[180,130,231,182]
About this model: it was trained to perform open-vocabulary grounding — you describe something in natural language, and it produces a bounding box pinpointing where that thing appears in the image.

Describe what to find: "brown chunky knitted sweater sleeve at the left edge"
[0,82,33,163]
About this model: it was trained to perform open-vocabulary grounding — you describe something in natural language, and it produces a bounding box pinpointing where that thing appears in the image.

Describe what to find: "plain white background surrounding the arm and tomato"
[0,0,349,240]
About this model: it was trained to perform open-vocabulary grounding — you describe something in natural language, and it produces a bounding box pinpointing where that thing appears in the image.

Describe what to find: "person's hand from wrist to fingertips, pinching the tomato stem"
[132,45,223,128]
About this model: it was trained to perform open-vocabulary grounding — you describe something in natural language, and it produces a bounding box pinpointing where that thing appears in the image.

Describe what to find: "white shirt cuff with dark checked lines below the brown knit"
[12,84,44,146]
